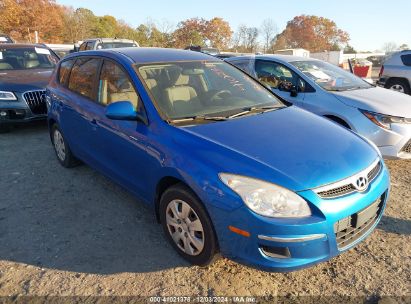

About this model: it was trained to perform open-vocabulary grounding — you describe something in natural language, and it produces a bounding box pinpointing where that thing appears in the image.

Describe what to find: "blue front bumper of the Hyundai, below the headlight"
[211,165,389,272]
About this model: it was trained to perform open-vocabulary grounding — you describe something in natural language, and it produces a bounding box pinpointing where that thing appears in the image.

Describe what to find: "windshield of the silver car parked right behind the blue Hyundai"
[291,60,372,91]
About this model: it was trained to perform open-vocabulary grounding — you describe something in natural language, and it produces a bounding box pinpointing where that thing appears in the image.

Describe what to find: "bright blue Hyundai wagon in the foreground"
[47,48,389,271]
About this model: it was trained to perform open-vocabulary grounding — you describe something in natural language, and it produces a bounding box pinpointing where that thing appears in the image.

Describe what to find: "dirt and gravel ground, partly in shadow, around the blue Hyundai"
[0,124,411,303]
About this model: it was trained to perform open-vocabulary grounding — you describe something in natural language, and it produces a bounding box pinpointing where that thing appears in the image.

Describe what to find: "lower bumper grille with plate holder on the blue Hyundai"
[334,195,385,249]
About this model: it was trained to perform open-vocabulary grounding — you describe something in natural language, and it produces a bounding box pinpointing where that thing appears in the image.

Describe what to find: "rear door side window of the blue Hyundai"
[69,58,100,99]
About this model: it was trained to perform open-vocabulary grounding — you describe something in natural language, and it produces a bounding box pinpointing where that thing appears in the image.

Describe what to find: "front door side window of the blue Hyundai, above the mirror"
[98,61,138,109]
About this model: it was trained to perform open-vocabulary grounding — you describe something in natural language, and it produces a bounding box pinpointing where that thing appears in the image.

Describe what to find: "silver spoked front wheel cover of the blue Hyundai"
[166,200,204,256]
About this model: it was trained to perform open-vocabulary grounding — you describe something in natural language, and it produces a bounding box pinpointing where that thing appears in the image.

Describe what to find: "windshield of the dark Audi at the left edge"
[0,46,59,70]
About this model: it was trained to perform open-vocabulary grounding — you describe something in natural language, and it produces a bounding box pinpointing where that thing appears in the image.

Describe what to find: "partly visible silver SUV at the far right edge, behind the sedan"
[377,51,411,94]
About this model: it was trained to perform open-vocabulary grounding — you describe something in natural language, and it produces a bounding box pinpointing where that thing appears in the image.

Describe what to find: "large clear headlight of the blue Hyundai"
[219,173,311,218]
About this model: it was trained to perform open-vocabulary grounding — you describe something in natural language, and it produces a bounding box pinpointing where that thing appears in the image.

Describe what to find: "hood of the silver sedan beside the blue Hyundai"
[332,87,411,118]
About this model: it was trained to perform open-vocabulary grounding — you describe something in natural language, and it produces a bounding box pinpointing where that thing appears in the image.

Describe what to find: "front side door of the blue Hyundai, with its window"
[94,60,159,197]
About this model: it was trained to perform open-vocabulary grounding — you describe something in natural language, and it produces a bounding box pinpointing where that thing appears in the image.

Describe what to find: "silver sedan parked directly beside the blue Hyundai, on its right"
[226,55,411,159]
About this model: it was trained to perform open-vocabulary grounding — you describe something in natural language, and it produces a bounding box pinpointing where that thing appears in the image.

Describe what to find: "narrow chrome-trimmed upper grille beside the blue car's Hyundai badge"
[314,161,382,199]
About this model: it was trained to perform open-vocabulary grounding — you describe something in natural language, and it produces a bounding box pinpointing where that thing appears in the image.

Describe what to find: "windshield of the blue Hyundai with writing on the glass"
[137,61,284,120]
